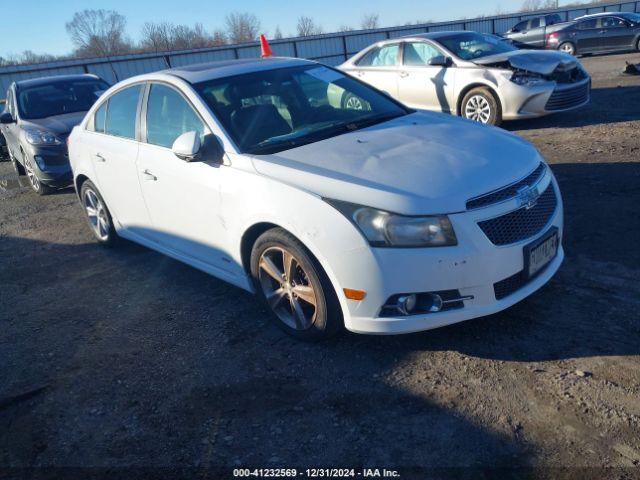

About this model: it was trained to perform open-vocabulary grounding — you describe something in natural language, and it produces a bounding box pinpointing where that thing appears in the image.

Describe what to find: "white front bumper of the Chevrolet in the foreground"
[340,171,564,334]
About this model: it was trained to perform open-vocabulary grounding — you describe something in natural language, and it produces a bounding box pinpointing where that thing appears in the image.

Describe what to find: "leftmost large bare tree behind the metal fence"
[66,9,131,56]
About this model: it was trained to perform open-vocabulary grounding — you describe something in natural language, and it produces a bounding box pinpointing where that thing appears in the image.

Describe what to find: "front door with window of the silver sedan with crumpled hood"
[398,41,456,113]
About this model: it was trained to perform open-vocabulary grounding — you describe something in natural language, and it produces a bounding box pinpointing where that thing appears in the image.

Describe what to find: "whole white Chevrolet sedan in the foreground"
[69,58,564,339]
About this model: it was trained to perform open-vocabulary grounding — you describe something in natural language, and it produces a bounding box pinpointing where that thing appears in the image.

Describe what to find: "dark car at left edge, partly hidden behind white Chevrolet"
[0,75,109,195]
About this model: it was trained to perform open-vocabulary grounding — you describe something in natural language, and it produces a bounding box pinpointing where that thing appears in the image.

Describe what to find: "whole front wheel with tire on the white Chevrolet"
[250,228,343,341]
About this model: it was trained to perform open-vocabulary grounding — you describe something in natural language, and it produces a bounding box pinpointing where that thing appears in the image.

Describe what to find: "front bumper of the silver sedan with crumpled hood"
[501,78,591,120]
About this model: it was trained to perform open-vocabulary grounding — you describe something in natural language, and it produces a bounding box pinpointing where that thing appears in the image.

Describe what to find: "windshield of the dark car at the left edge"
[17,79,109,120]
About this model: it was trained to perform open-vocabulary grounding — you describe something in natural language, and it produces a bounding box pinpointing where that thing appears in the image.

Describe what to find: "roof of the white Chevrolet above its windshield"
[161,57,318,83]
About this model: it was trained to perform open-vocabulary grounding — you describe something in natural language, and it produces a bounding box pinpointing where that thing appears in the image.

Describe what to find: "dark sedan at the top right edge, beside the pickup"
[547,12,640,55]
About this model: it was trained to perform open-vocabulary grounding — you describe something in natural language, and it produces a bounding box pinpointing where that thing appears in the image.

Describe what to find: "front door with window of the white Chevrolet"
[138,83,233,272]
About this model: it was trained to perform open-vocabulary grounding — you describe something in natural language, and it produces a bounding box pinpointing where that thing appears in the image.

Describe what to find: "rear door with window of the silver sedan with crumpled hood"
[348,42,400,98]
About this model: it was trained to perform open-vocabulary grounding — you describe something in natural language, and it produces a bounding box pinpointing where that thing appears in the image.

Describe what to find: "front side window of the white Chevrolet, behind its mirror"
[147,84,206,148]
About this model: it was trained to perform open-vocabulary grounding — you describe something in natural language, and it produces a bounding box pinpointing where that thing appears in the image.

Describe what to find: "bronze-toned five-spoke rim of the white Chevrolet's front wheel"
[259,247,318,330]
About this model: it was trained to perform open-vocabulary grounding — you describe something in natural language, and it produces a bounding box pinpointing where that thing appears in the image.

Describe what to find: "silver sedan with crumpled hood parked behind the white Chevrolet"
[332,31,591,125]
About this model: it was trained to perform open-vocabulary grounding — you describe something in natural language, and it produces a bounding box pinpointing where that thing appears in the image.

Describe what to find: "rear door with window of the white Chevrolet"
[84,84,149,236]
